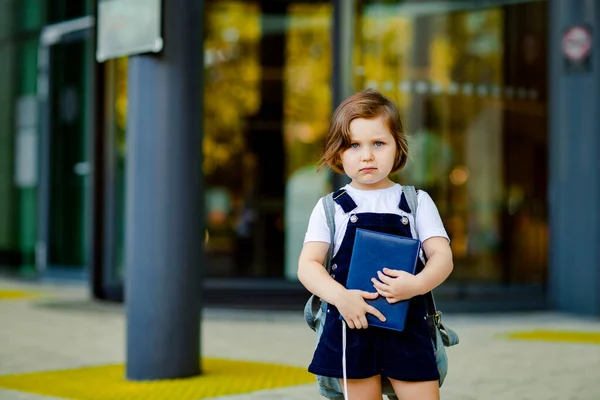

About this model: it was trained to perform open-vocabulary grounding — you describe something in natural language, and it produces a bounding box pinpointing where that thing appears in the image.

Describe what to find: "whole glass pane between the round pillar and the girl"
[204,1,332,279]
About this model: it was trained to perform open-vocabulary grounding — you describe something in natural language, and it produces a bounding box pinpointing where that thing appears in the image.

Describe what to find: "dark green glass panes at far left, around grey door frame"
[0,0,92,275]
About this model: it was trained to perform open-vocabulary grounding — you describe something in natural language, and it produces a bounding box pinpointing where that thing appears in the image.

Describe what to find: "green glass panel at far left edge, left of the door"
[0,0,46,274]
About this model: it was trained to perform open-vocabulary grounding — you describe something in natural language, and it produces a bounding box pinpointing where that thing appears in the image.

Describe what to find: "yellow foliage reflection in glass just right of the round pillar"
[203,1,261,175]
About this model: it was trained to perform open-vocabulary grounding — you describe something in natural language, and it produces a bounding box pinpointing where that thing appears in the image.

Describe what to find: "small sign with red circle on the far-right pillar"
[561,25,592,72]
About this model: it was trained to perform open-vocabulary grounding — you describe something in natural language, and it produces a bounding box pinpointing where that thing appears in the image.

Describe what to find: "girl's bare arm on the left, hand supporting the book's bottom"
[298,242,385,329]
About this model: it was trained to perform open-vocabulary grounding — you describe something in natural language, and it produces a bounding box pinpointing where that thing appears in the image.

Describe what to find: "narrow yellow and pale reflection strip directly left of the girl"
[283,3,332,280]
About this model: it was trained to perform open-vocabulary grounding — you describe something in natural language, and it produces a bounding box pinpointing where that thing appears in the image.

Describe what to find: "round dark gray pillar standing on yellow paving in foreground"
[125,0,203,380]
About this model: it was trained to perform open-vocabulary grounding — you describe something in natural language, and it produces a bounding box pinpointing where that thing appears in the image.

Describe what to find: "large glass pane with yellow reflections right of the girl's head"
[355,1,548,283]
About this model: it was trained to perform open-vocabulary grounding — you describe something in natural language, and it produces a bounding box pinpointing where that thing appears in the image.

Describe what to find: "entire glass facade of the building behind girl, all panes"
[0,0,548,306]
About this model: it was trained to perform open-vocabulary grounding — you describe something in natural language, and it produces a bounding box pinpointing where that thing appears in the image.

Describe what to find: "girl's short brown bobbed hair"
[319,89,408,174]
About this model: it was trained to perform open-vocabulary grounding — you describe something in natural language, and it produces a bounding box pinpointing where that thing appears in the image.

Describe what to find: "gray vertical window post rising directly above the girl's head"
[331,0,356,190]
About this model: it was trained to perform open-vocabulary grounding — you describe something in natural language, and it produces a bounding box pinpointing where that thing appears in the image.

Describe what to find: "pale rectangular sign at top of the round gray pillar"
[96,0,163,62]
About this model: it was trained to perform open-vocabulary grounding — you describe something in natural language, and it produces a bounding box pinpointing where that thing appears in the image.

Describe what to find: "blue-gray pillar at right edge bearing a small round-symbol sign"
[548,0,600,315]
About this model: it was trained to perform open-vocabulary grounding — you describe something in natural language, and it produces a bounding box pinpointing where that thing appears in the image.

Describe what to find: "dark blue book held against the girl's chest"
[340,228,421,331]
